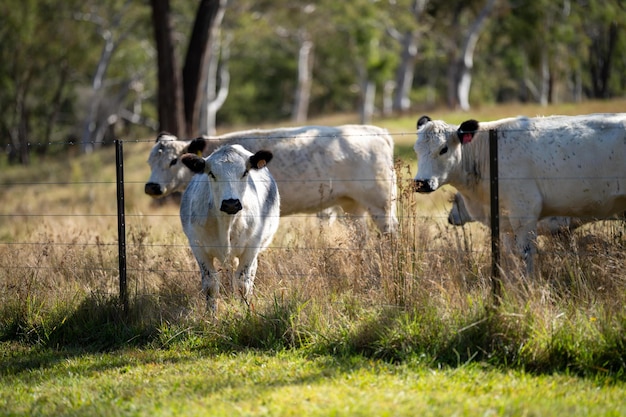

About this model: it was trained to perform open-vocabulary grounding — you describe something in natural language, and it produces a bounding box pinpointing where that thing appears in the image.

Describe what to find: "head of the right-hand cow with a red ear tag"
[413,116,478,193]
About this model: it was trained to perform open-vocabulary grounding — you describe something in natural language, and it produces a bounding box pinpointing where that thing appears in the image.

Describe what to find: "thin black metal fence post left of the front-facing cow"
[115,140,128,313]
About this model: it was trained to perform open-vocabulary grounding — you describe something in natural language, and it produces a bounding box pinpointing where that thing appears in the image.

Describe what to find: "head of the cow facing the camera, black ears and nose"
[181,145,273,214]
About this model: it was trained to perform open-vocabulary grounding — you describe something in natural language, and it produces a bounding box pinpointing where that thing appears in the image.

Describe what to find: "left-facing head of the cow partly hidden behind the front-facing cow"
[144,132,205,198]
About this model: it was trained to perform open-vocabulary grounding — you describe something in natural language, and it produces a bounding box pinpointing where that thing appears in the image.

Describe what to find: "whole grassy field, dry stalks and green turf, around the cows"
[0,100,626,416]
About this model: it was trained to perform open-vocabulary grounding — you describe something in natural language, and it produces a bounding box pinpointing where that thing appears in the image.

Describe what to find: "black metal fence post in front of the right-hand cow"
[489,129,502,304]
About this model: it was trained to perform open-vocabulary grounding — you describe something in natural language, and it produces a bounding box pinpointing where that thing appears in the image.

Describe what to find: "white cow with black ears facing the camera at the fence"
[180,145,280,314]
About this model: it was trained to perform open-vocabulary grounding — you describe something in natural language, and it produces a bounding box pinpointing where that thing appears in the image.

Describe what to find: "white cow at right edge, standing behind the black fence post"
[414,113,626,273]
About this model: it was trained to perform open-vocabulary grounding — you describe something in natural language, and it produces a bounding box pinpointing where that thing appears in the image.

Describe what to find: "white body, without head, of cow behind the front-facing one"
[205,125,396,215]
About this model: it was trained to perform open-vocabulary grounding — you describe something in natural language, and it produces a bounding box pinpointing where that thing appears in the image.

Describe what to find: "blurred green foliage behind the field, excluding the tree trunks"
[0,0,626,153]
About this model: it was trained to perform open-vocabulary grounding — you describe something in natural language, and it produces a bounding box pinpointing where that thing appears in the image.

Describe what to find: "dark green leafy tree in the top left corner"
[0,0,90,164]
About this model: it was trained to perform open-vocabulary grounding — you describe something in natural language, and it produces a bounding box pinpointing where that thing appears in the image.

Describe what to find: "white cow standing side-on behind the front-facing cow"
[145,125,398,233]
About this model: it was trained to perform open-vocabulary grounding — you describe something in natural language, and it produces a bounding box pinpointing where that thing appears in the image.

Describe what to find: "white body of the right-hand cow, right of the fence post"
[490,114,626,217]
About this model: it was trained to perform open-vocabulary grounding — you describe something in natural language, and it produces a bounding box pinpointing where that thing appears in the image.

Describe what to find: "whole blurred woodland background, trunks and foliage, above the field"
[0,0,626,164]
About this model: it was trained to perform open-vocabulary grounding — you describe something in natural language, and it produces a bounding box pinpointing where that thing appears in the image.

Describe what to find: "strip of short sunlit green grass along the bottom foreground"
[0,344,626,416]
